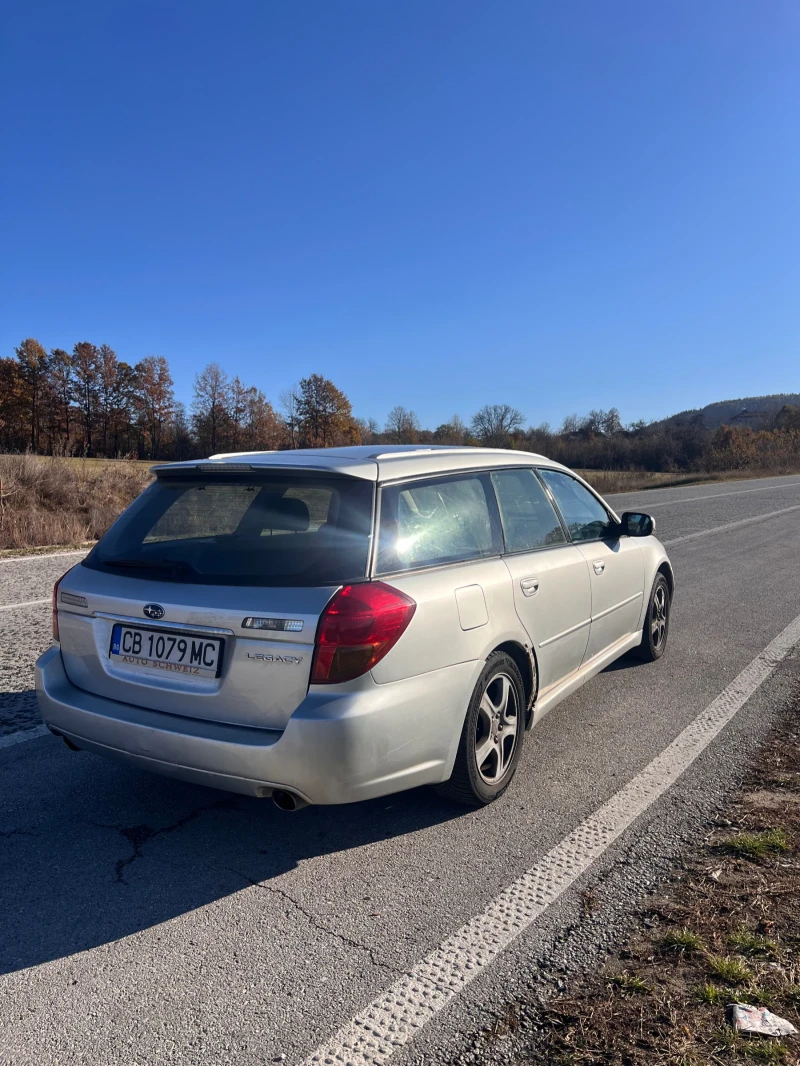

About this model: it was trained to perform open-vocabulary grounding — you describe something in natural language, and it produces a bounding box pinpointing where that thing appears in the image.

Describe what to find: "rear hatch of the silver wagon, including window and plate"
[58,465,374,729]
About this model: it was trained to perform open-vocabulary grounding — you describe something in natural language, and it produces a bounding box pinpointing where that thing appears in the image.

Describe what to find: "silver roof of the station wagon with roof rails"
[154,445,564,481]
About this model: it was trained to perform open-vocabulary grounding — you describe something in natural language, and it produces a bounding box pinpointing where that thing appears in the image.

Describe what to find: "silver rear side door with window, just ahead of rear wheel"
[492,468,591,692]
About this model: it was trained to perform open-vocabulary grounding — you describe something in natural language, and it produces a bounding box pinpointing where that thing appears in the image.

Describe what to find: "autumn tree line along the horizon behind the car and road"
[0,338,800,471]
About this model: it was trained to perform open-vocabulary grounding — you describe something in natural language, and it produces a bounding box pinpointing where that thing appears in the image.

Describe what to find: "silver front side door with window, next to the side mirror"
[540,469,644,659]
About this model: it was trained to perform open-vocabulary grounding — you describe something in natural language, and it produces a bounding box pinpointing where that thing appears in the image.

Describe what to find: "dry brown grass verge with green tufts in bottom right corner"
[499,708,800,1066]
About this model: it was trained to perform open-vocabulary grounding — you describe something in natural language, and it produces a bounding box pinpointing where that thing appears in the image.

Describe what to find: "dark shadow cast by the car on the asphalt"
[0,690,465,973]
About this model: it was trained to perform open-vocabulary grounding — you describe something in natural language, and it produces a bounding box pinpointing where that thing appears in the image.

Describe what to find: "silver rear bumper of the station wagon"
[36,647,475,804]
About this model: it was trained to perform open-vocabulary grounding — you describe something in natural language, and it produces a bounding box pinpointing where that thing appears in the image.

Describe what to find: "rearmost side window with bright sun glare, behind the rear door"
[378,474,495,574]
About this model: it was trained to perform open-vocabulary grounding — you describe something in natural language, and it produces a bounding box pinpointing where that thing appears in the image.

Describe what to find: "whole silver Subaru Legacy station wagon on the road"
[36,447,673,810]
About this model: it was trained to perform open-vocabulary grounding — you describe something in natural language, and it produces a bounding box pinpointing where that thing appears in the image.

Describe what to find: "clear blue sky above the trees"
[0,0,800,427]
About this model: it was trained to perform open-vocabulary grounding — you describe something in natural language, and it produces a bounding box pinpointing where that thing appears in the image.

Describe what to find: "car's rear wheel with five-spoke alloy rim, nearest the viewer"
[435,651,526,807]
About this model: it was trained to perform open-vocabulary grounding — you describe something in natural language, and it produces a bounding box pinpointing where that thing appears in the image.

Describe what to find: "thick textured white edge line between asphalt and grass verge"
[304,615,800,1066]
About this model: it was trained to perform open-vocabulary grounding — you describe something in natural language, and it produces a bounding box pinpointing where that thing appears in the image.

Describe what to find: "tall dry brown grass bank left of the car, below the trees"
[0,455,150,549]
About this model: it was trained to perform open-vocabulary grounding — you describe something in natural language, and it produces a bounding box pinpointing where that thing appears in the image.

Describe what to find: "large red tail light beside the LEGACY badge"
[311,581,417,684]
